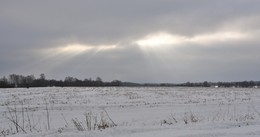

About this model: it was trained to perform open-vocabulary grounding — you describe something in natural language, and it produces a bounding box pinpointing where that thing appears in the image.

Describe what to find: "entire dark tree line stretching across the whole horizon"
[0,74,260,88]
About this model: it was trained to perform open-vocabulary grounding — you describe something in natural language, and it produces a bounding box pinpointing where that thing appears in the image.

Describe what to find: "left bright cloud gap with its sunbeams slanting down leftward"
[16,44,120,72]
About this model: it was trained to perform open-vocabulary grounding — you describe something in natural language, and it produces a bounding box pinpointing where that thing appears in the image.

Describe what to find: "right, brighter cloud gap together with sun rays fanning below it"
[133,30,250,76]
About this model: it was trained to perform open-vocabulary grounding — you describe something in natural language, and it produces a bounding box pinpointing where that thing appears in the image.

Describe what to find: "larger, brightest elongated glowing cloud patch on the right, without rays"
[134,31,249,47]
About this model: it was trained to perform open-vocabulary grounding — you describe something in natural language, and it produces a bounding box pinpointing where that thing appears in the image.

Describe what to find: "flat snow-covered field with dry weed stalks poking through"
[0,87,260,137]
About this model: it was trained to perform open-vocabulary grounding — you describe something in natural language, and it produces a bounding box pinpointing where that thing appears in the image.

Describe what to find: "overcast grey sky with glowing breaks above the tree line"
[0,0,260,83]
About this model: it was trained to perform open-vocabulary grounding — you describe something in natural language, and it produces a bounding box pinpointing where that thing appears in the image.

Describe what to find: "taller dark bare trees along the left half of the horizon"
[0,74,122,88]
